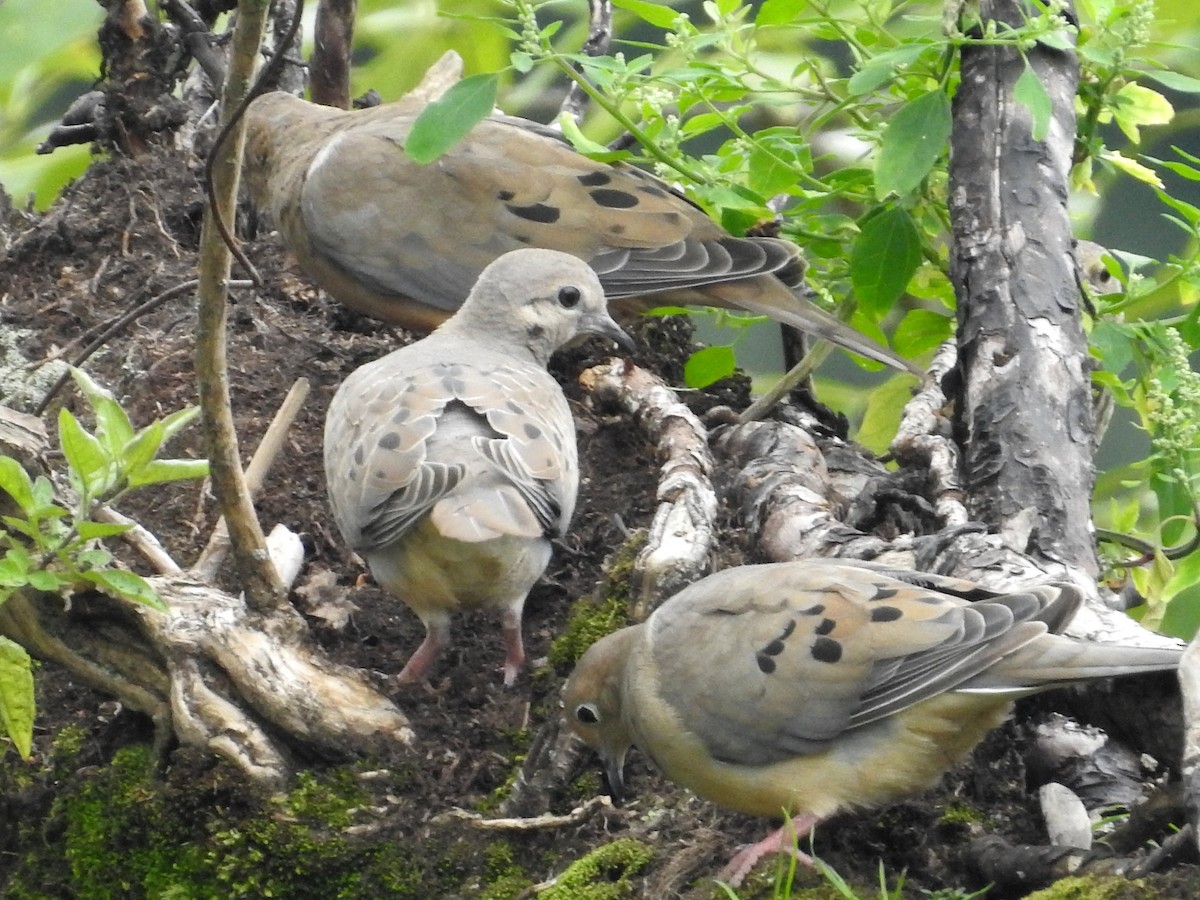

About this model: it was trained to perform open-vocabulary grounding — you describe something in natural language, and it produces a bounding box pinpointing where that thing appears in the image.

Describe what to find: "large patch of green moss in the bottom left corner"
[0,736,480,900]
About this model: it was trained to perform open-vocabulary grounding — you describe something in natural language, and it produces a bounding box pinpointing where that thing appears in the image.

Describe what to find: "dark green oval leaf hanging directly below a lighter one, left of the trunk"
[850,206,920,319]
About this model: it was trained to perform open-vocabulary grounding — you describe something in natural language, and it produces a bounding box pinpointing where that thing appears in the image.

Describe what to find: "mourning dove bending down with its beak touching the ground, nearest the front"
[564,562,1181,884]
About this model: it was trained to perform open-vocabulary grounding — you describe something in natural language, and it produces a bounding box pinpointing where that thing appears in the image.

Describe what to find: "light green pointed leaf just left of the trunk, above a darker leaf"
[875,90,950,198]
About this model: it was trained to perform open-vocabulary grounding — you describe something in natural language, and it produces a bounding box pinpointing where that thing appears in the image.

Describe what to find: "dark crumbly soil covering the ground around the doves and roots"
[0,146,1194,898]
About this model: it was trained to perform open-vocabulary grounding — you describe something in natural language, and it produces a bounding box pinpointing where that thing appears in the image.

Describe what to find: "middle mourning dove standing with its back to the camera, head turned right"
[325,250,630,685]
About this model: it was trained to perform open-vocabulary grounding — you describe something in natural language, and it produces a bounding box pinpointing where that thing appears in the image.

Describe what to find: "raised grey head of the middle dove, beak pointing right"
[443,250,634,365]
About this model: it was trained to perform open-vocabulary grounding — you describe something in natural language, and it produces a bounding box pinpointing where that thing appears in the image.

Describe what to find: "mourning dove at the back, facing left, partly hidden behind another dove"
[245,92,922,376]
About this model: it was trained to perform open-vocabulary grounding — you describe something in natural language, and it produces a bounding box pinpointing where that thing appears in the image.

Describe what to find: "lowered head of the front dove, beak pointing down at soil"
[563,625,641,803]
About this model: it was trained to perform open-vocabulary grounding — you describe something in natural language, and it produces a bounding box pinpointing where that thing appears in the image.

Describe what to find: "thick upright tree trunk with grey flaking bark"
[949,0,1098,578]
